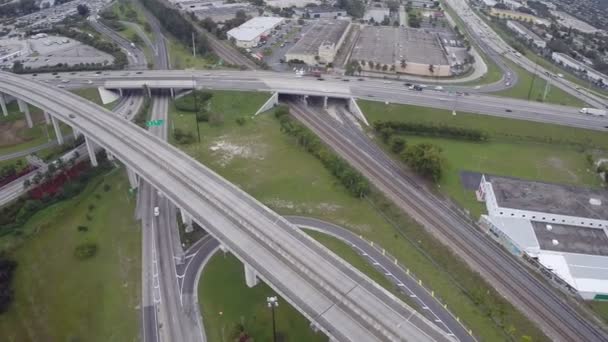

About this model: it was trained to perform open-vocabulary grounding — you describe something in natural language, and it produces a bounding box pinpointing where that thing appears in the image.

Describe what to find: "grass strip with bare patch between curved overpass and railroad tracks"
[170,92,542,341]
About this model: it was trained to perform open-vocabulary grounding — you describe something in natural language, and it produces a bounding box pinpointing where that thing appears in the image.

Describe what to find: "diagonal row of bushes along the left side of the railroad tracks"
[275,106,370,197]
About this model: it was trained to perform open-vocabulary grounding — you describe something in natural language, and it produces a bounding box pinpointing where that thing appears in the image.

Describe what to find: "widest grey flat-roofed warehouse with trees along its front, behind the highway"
[351,26,452,77]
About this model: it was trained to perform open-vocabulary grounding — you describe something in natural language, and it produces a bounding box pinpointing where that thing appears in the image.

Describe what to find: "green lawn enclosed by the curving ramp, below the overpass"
[198,252,328,342]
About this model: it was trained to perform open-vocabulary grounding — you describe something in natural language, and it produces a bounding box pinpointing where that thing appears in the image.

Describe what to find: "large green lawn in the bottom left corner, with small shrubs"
[0,169,141,342]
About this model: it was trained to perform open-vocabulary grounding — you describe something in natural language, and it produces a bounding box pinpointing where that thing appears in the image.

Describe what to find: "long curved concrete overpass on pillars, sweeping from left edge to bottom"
[0,73,455,341]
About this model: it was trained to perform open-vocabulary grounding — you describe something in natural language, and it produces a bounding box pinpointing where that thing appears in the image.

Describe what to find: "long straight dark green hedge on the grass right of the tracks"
[374,121,488,141]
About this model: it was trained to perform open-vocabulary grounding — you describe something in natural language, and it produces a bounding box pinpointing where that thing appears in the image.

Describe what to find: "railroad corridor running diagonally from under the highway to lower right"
[291,103,608,341]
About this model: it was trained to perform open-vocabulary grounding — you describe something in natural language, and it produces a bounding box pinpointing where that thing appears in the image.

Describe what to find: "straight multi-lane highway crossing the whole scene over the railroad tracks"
[34,70,608,131]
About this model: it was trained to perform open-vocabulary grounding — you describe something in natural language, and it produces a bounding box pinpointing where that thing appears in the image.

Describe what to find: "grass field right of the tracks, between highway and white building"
[360,102,608,218]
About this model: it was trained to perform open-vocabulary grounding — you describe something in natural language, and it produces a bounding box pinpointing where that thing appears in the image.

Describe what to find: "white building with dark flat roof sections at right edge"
[477,175,608,300]
